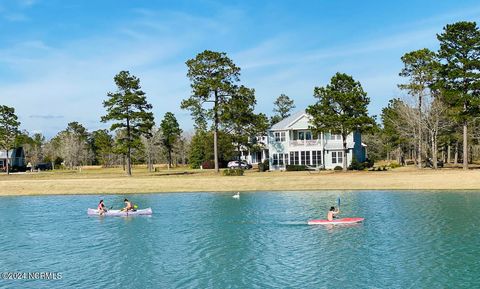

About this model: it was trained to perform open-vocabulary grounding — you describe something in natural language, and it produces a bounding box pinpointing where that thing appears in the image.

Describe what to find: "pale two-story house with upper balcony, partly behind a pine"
[268,111,366,170]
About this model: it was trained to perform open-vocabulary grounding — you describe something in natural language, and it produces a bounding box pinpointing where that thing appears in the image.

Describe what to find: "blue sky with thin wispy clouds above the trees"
[0,0,480,137]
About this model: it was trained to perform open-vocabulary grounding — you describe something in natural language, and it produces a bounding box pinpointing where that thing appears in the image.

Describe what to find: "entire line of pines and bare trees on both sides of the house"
[0,22,480,175]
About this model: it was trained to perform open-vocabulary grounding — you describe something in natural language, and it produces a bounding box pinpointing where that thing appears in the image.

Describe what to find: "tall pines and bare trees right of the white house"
[368,21,480,169]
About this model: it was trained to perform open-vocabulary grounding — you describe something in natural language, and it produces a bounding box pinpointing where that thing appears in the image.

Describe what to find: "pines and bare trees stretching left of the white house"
[0,50,294,175]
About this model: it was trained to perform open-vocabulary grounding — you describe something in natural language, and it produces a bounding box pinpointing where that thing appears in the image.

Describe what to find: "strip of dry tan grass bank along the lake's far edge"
[0,168,480,196]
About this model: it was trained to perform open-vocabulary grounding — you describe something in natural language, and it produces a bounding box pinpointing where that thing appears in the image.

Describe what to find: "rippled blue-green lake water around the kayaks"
[0,191,480,288]
